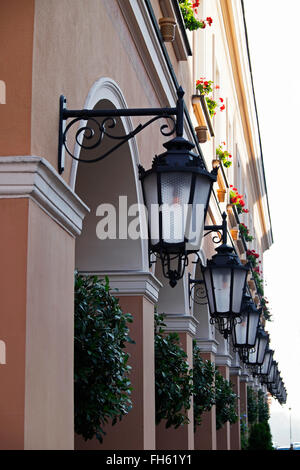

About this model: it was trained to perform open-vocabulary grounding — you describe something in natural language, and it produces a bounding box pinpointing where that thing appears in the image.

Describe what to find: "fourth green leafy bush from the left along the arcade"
[215,370,238,429]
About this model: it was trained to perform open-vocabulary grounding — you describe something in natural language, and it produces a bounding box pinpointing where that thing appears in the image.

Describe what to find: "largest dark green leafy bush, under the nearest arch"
[74,274,133,442]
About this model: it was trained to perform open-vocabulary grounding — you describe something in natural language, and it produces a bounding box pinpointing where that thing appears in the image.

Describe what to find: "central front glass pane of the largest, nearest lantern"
[161,172,192,243]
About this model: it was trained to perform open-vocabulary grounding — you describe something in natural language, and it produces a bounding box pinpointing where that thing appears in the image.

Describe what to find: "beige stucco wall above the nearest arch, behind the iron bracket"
[31,0,178,185]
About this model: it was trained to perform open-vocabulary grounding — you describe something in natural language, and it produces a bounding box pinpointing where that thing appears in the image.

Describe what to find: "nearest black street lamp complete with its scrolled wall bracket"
[58,87,218,287]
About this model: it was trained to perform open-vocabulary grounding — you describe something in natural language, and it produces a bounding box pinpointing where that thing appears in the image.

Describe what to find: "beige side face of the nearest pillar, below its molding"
[25,197,75,449]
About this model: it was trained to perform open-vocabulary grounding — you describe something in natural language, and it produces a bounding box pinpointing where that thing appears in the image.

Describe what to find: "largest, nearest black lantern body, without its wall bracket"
[140,136,217,287]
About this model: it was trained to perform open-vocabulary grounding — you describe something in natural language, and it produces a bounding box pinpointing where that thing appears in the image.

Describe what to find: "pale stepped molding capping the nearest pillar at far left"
[0,156,89,236]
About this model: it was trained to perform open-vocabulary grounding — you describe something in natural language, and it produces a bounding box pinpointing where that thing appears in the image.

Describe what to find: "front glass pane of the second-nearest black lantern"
[212,268,231,314]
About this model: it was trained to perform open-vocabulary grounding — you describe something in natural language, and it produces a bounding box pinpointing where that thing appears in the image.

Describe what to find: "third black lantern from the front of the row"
[232,294,261,357]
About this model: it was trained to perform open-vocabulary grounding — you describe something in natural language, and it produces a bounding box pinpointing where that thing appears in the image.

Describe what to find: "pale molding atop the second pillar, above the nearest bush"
[81,271,162,303]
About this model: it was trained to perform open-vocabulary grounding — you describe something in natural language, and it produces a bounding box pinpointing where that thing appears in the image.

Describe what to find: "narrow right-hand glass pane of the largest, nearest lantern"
[186,175,211,250]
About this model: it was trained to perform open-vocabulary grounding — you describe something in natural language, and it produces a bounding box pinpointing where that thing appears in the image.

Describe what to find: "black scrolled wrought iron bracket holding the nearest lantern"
[58,87,184,174]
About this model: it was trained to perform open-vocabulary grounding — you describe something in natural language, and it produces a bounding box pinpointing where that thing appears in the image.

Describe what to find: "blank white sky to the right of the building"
[243,0,300,446]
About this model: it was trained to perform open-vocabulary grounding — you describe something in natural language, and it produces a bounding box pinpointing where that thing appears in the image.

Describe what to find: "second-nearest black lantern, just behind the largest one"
[202,244,249,319]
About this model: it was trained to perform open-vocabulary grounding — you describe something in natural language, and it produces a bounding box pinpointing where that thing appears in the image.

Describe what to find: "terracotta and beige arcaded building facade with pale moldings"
[0,0,282,449]
